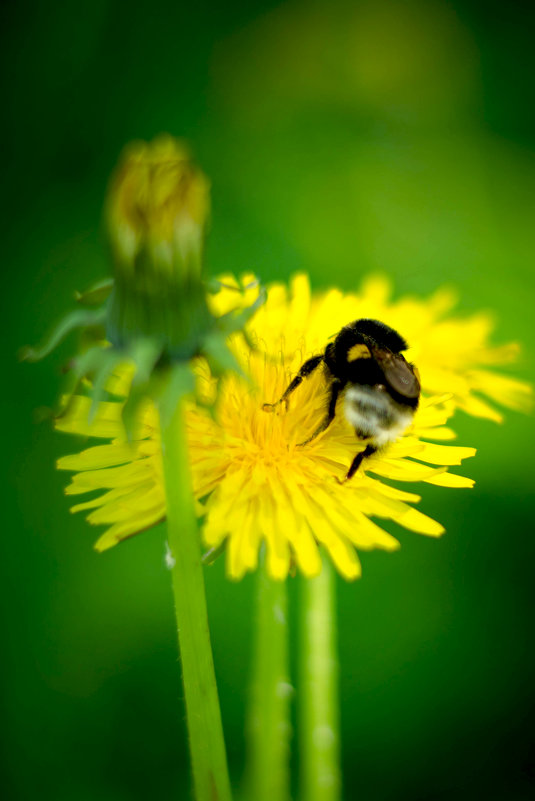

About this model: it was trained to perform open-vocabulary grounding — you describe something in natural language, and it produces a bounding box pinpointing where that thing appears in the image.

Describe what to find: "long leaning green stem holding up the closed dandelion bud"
[160,403,231,801]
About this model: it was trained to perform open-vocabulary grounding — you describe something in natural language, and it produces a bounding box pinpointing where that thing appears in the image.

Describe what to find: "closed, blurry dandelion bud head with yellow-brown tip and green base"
[107,135,210,358]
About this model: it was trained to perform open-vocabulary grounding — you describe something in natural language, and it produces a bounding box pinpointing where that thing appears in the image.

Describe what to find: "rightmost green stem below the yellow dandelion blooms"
[299,555,341,801]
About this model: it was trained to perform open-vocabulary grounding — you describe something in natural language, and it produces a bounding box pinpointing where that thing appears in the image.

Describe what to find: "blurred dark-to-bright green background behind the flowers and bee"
[0,0,535,801]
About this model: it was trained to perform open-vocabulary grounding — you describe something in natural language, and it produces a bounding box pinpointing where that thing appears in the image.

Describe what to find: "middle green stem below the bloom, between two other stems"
[246,565,293,801]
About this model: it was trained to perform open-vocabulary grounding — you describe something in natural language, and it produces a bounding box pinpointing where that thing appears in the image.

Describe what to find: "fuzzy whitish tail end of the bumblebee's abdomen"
[344,384,414,447]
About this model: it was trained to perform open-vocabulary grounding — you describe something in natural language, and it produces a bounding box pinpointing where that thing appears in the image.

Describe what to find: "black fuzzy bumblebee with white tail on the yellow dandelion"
[264,319,420,481]
